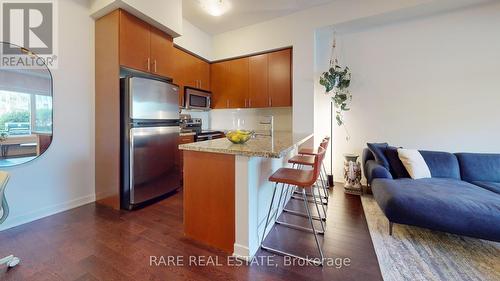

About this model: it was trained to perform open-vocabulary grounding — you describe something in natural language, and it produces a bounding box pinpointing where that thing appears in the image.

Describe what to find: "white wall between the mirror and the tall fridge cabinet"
[0,0,95,229]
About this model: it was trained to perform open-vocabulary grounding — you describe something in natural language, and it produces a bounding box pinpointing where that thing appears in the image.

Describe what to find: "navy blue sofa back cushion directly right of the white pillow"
[420,150,460,180]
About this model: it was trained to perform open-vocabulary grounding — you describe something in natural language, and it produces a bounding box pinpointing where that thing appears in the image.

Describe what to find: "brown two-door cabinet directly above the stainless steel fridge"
[119,10,174,78]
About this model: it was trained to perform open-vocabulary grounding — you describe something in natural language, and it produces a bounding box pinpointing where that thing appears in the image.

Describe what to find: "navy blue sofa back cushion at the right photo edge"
[455,153,500,182]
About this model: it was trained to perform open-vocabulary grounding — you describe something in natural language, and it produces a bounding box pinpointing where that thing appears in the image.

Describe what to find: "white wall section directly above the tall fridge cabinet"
[90,0,182,37]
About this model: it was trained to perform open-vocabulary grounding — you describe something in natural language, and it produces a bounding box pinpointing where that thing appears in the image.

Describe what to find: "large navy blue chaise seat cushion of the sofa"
[371,178,500,242]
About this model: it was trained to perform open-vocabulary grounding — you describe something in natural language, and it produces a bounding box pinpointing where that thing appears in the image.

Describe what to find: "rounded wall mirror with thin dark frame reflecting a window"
[0,42,52,168]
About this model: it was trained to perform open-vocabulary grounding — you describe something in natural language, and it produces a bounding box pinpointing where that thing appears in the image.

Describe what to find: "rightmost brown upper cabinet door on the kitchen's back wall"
[268,49,292,107]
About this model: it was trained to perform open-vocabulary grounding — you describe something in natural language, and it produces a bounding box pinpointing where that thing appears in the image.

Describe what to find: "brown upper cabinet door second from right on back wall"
[247,54,269,108]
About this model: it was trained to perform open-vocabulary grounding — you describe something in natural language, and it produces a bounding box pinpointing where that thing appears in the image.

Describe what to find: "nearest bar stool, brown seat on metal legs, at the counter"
[261,147,326,266]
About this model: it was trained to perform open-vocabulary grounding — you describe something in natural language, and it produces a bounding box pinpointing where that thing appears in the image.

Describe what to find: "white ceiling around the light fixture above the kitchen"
[182,0,334,35]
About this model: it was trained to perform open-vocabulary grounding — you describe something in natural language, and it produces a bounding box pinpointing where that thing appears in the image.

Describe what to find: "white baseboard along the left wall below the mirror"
[0,194,95,231]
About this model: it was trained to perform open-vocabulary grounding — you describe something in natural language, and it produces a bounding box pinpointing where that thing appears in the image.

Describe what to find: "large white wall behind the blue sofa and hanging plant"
[316,2,500,180]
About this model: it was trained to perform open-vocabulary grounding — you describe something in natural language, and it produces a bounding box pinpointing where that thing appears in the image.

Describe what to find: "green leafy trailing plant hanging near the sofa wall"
[319,64,352,126]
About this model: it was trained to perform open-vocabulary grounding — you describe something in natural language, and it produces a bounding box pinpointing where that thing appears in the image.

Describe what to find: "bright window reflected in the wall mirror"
[0,90,52,136]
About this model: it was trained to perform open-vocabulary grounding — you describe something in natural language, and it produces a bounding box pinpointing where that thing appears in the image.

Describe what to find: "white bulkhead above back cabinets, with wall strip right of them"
[213,0,446,136]
